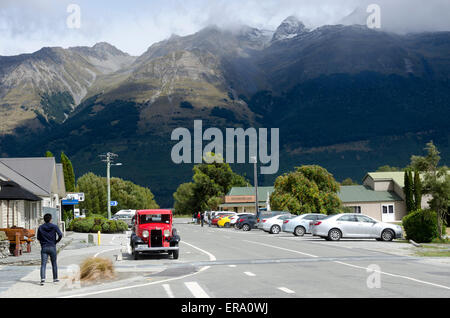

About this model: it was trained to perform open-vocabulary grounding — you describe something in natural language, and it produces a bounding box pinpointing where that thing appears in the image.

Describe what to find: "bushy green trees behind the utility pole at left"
[76,172,159,216]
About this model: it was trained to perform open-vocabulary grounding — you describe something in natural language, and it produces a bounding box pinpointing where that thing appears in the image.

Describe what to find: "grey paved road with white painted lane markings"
[0,224,450,298]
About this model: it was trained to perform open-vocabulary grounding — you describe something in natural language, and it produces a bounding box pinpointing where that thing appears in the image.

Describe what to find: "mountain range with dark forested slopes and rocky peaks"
[0,16,450,206]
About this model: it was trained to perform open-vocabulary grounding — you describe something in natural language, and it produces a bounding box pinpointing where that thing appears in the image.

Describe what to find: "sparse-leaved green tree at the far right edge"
[411,141,450,237]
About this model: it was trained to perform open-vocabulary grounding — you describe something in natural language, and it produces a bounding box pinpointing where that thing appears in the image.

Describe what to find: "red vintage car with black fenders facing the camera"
[130,209,180,259]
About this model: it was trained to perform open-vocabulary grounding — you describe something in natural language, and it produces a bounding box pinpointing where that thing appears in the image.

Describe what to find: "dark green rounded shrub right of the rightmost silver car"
[403,210,439,243]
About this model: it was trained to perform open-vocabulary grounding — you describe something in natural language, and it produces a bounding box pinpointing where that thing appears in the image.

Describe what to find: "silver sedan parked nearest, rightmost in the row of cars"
[311,213,402,241]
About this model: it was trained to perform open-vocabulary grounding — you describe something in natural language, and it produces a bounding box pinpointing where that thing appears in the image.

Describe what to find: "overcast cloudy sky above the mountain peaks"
[0,0,450,55]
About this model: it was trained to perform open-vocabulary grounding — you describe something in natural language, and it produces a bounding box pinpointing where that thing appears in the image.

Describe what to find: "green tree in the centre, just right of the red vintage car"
[174,155,247,214]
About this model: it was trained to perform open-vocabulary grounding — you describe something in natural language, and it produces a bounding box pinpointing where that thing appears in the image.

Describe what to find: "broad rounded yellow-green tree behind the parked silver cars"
[270,166,342,214]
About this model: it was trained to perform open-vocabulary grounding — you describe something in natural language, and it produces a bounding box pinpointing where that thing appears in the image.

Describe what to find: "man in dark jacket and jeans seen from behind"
[37,213,62,286]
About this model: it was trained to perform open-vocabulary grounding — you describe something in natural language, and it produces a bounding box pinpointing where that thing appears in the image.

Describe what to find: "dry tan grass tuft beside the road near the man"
[80,257,115,281]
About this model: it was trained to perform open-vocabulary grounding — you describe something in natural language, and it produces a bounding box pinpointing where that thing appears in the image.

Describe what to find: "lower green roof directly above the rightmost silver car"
[338,185,403,203]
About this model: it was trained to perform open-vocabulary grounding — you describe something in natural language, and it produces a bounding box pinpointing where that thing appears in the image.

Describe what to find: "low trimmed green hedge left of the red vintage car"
[68,215,128,233]
